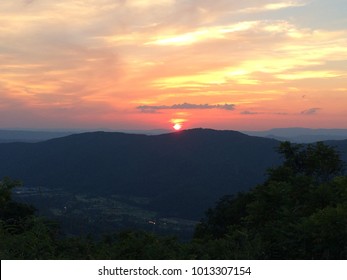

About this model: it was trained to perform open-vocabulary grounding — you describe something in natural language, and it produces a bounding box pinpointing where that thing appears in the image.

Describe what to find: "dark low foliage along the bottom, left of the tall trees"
[0,178,184,259]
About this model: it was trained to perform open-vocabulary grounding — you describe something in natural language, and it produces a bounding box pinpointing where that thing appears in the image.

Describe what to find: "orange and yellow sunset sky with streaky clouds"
[0,0,347,130]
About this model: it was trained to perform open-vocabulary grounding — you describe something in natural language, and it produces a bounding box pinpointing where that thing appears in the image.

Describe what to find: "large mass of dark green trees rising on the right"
[195,142,347,259]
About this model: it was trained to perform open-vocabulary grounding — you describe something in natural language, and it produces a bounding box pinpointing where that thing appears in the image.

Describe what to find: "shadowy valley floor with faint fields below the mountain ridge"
[13,187,198,240]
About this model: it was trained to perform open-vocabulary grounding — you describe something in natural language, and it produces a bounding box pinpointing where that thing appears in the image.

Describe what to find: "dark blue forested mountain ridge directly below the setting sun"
[0,129,347,222]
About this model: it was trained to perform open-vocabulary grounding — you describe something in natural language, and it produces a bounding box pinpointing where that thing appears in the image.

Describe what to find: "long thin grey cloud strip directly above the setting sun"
[136,103,235,113]
